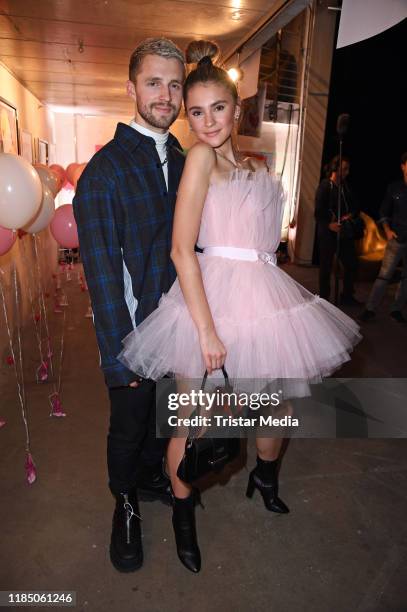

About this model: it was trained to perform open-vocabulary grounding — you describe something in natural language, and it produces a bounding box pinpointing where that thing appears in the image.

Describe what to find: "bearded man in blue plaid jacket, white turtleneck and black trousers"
[73,38,185,572]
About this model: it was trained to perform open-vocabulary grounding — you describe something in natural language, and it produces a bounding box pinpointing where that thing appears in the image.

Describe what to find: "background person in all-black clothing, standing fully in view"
[315,156,359,306]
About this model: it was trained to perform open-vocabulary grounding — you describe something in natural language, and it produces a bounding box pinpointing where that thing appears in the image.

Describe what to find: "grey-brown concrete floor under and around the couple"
[0,266,407,612]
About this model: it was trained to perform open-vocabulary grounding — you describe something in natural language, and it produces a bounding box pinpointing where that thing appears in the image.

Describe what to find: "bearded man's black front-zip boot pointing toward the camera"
[110,489,143,572]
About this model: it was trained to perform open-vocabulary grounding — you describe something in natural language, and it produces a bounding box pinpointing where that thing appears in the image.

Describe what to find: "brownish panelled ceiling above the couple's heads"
[0,0,284,115]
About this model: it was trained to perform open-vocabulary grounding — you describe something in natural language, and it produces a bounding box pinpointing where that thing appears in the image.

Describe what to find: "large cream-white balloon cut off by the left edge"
[0,153,42,229]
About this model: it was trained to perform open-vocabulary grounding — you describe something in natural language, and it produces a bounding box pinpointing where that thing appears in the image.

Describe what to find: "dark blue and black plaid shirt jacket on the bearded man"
[73,123,184,387]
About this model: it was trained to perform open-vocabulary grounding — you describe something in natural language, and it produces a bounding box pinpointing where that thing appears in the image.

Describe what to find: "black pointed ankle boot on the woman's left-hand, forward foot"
[172,491,201,573]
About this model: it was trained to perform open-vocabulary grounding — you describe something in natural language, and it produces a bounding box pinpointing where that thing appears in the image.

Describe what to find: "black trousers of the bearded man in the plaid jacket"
[107,380,168,494]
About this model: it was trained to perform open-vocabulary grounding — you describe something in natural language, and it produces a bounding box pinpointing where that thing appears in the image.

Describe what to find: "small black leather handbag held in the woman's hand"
[177,368,240,483]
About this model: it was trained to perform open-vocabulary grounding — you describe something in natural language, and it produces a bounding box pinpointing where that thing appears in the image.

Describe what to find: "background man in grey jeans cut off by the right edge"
[359,152,407,323]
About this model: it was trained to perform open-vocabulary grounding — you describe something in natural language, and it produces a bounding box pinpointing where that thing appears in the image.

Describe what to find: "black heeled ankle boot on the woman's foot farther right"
[246,457,289,514]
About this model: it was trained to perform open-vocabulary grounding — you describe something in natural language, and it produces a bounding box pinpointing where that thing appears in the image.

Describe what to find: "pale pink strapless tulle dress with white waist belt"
[119,169,361,396]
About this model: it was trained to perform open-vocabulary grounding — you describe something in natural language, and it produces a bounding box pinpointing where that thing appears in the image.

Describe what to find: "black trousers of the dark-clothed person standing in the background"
[318,228,358,300]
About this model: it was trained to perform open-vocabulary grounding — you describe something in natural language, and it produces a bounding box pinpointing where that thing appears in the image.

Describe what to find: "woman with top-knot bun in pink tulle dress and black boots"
[119,41,360,572]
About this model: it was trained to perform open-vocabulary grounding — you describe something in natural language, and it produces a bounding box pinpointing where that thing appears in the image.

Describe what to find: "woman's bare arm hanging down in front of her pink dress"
[171,143,226,374]
